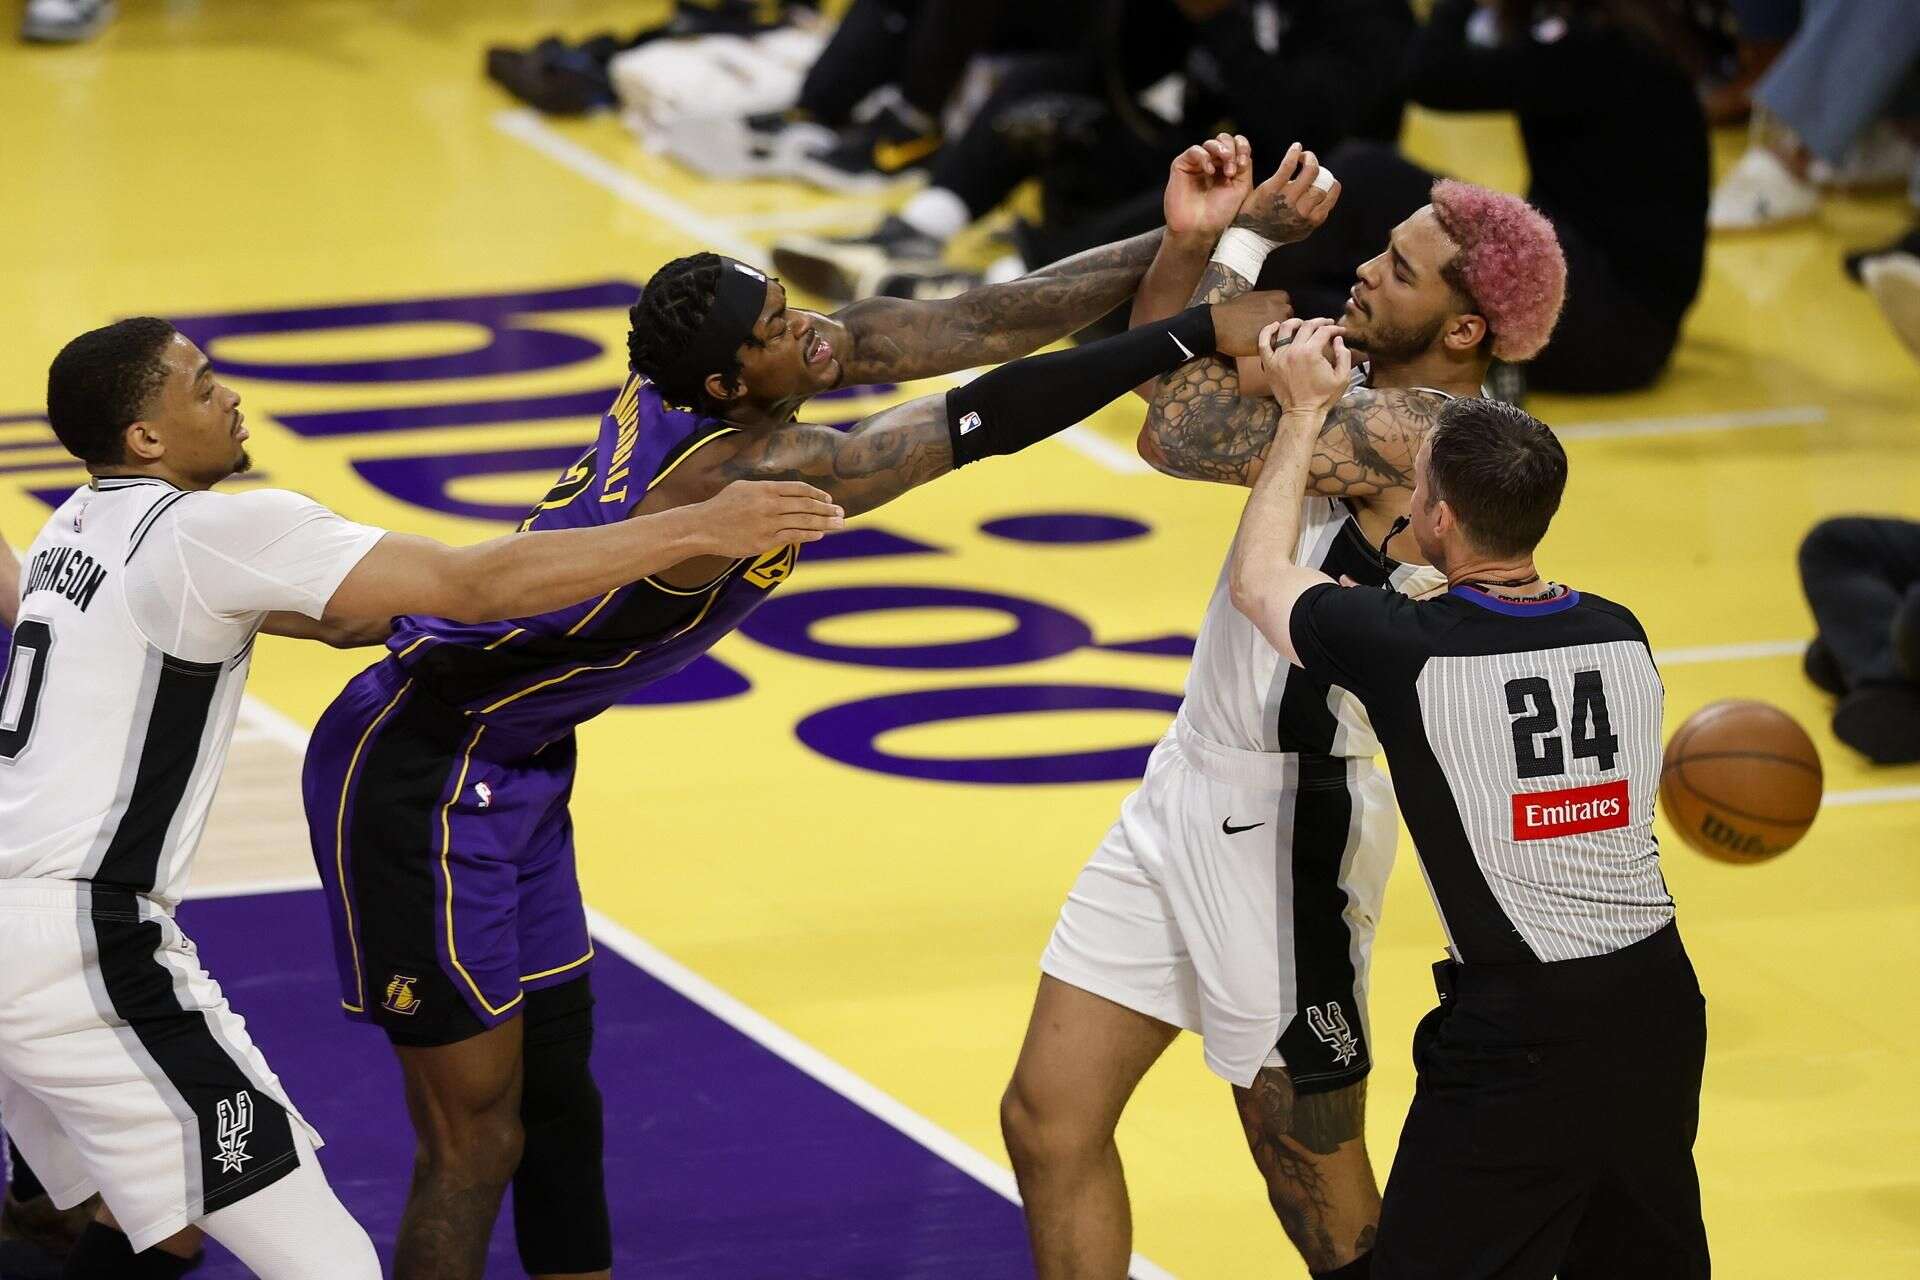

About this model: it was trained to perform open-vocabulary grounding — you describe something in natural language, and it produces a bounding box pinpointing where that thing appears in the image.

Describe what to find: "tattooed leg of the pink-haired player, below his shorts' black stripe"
[1233,1067,1375,1270]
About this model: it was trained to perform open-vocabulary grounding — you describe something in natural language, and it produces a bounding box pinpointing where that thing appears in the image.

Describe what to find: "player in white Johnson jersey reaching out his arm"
[0,319,839,1280]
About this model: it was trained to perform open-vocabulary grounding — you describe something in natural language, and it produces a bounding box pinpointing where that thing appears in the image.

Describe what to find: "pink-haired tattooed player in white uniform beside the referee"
[1002,140,1565,1280]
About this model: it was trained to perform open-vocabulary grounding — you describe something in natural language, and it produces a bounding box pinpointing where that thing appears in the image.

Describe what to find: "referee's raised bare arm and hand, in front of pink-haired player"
[1227,320,1354,666]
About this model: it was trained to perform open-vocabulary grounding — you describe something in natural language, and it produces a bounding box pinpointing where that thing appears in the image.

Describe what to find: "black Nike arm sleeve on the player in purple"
[947,307,1213,466]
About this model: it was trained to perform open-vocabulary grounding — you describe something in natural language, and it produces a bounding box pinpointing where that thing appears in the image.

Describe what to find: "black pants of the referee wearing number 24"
[1373,925,1709,1280]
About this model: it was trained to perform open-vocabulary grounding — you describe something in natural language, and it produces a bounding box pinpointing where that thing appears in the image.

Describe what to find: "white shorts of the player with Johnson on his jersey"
[0,879,321,1251]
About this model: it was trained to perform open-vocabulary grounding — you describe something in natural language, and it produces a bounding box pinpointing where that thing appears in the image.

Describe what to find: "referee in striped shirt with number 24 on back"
[1229,320,1709,1280]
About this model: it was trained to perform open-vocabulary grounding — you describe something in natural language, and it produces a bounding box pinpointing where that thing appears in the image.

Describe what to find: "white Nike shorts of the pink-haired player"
[1041,720,1398,1092]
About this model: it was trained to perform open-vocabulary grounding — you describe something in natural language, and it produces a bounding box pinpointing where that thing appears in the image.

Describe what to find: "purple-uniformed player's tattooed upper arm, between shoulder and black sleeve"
[718,393,954,516]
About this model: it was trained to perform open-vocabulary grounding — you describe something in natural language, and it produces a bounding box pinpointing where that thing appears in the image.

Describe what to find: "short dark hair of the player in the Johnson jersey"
[46,315,177,466]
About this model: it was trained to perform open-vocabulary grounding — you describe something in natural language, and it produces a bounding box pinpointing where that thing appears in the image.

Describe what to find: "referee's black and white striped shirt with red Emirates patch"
[1290,585,1674,963]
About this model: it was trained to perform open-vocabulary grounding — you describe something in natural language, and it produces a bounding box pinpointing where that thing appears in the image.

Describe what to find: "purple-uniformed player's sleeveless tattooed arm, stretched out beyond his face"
[829,230,1162,386]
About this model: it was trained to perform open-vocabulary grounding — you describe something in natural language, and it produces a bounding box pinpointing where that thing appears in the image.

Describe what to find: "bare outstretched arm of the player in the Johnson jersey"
[323,480,845,626]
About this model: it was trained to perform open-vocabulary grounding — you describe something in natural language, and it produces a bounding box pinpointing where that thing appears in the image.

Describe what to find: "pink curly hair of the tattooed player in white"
[1432,178,1567,361]
